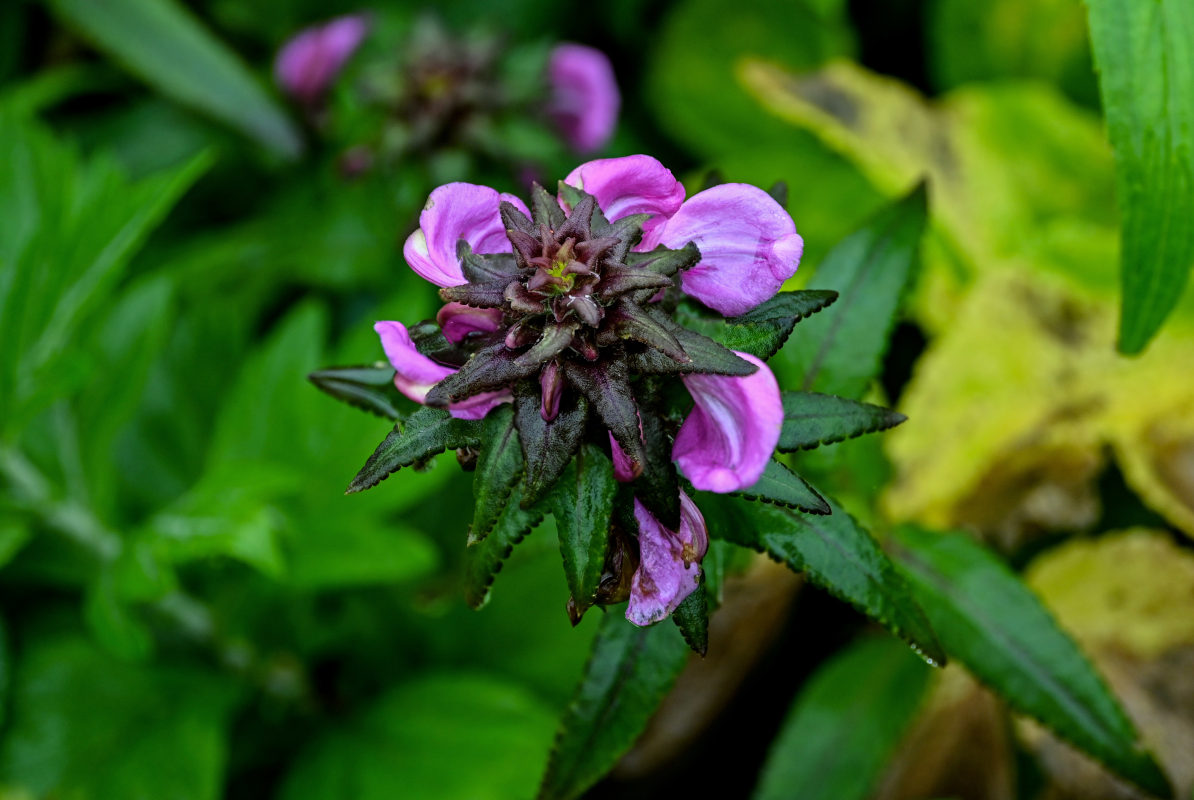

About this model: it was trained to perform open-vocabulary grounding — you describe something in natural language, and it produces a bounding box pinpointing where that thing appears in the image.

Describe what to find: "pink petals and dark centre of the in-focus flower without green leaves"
[375,155,804,626]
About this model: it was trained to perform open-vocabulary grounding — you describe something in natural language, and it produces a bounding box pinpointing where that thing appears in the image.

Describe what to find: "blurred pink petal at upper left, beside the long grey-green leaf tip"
[273,14,369,104]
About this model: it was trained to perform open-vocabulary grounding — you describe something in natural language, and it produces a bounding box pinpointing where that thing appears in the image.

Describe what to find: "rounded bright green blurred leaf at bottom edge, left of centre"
[279,673,554,800]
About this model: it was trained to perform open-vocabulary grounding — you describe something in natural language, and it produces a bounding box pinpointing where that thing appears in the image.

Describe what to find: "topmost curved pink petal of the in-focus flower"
[564,155,684,230]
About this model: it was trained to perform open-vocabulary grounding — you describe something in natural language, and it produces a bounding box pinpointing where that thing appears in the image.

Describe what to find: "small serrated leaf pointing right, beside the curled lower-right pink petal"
[776,392,907,453]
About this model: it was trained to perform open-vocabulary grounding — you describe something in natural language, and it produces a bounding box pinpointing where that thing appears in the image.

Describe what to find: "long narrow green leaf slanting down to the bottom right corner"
[896,527,1173,796]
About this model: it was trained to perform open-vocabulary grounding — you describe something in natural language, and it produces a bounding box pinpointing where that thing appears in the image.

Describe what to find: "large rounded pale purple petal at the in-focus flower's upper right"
[656,184,805,316]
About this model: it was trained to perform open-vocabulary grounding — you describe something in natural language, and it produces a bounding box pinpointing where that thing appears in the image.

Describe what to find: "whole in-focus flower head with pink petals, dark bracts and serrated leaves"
[313,155,903,651]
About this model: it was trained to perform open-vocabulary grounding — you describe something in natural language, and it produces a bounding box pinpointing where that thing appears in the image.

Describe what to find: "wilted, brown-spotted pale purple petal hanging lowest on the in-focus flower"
[626,492,709,626]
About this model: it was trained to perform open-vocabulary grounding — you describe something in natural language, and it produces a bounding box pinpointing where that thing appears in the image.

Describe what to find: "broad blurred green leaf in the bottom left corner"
[0,636,233,800]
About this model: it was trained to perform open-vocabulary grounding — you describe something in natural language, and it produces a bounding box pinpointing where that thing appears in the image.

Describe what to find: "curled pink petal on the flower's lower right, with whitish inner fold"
[672,352,783,492]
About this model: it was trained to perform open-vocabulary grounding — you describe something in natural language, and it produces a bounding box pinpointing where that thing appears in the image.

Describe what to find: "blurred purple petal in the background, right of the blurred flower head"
[547,44,622,153]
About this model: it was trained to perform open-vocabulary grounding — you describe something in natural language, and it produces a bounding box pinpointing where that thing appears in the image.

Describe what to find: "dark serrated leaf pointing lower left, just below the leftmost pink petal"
[346,407,480,494]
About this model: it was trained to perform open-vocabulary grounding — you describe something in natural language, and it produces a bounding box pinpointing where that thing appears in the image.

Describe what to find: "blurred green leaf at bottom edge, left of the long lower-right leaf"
[753,638,930,800]
